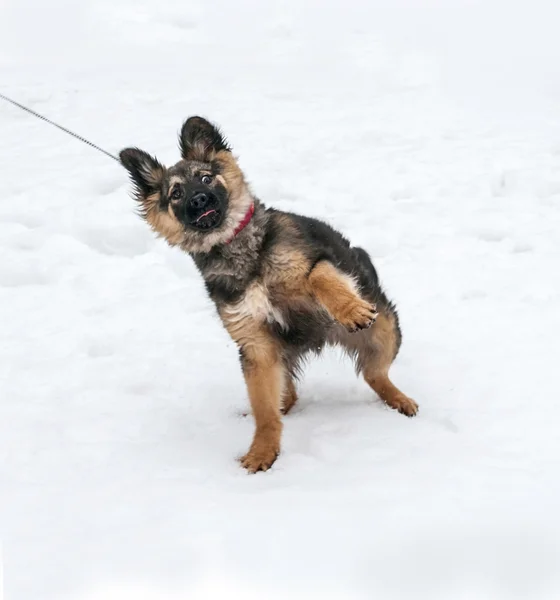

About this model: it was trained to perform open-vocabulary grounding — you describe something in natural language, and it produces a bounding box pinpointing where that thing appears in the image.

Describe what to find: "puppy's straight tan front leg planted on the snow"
[241,334,285,473]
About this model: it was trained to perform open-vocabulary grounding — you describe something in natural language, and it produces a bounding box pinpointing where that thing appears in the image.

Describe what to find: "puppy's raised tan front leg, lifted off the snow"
[308,261,376,331]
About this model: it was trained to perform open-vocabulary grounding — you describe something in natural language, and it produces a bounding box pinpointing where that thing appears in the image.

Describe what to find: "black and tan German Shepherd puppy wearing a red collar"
[119,117,418,473]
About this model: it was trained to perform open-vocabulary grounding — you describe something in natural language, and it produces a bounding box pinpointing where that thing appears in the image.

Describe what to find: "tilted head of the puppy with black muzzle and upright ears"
[120,117,253,252]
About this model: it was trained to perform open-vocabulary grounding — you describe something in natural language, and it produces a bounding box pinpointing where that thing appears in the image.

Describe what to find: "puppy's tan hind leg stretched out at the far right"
[357,308,418,417]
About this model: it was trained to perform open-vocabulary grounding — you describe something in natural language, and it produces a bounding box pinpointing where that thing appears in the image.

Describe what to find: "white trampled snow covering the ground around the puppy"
[0,0,560,600]
